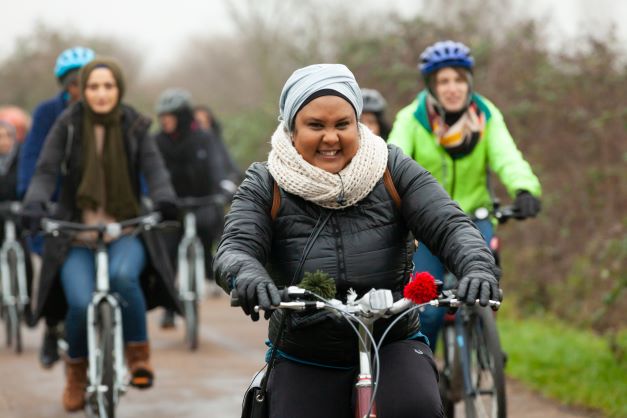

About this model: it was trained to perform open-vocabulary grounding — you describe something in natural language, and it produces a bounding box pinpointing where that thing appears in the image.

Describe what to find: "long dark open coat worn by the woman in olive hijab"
[24,102,178,322]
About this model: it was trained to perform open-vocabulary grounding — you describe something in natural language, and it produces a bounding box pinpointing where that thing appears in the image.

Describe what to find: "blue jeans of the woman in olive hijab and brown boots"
[61,236,148,359]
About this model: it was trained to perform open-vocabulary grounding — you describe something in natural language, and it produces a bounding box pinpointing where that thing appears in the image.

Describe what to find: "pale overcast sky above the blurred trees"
[0,0,627,73]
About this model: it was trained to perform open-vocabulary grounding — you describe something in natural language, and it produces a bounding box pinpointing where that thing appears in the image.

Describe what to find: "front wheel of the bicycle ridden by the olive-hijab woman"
[96,302,116,418]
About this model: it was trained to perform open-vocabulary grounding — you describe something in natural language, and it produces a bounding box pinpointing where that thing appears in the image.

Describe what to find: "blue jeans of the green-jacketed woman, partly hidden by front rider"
[414,219,494,352]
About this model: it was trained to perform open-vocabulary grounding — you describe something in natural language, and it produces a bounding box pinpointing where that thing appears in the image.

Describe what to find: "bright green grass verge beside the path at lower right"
[497,305,627,418]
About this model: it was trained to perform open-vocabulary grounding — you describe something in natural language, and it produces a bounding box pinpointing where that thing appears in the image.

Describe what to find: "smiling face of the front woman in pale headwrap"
[292,96,359,174]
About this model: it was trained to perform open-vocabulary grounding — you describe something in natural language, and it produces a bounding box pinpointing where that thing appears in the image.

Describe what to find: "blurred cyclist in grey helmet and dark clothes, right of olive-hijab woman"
[155,89,234,328]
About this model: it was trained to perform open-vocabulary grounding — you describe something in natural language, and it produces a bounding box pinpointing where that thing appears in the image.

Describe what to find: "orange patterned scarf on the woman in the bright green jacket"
[427,94,486,158]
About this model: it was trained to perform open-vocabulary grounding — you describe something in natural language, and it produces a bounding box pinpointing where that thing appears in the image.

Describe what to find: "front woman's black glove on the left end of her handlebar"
[234,275,281,321]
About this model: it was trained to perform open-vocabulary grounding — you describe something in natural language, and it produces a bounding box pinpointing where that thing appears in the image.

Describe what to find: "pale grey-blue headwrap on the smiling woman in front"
[279,64,363,129]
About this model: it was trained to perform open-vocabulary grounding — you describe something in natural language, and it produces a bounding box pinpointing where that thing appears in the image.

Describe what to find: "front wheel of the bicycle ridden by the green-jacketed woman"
[464,307,507,418]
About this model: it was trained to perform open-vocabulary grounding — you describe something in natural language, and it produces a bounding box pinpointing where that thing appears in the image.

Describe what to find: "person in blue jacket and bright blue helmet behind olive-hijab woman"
[17,46,95,369]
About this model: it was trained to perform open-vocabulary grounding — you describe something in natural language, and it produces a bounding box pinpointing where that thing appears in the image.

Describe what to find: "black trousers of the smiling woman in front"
[268,340,444,418]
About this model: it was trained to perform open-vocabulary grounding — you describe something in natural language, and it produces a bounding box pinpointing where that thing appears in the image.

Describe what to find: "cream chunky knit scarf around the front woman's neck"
[268,123,388,209]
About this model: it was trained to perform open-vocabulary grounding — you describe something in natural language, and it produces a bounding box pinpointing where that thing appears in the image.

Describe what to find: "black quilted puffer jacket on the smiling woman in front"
[214,145,498,366]
